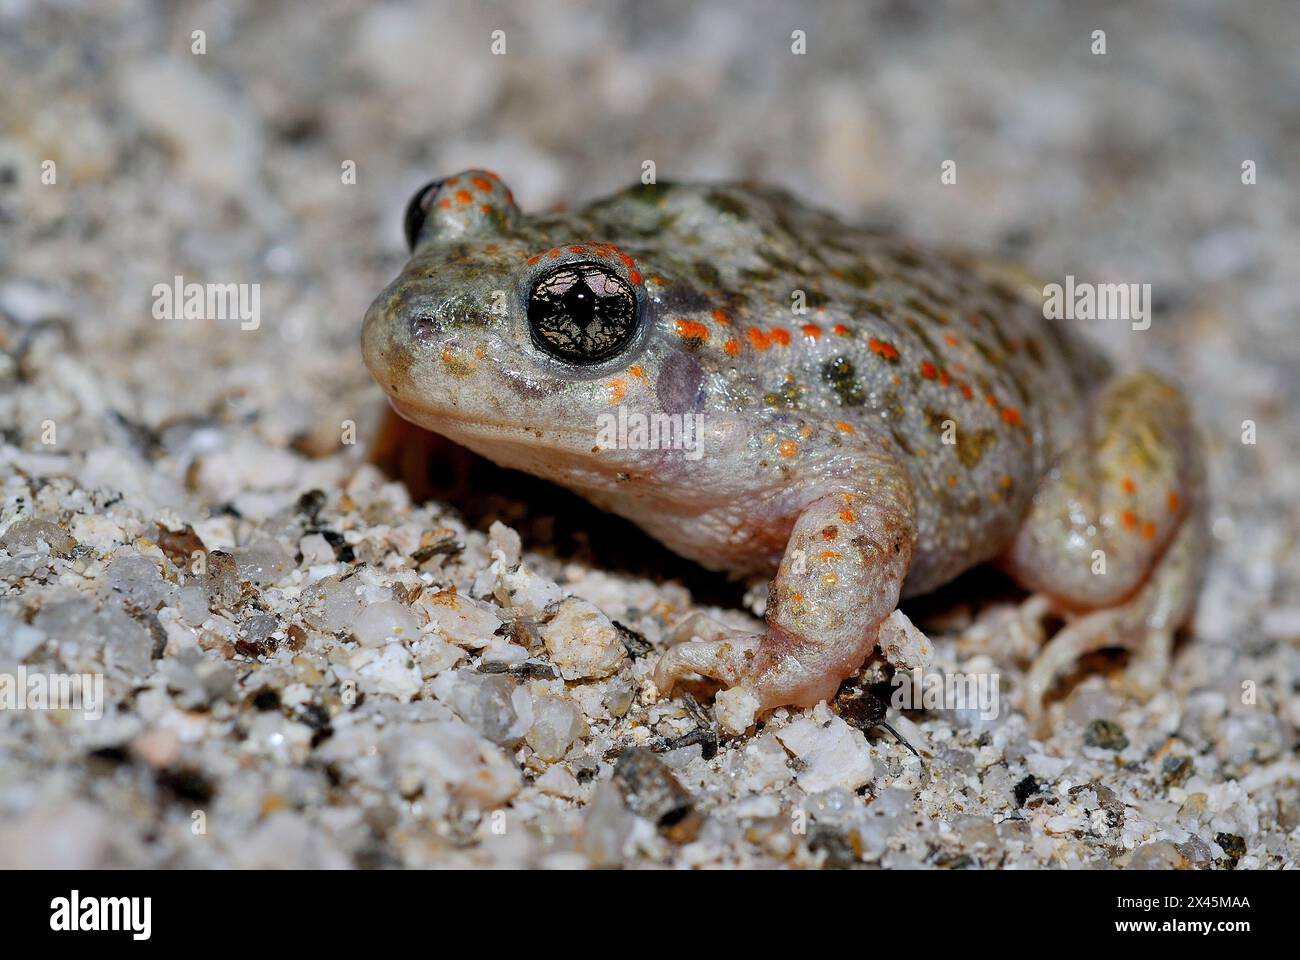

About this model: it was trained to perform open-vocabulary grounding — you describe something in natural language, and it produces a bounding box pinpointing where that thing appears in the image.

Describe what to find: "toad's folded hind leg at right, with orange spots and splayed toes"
[1004,373,1205,722]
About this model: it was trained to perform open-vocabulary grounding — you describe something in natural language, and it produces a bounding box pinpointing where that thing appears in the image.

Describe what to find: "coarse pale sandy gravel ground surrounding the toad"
[0,0,1300,869]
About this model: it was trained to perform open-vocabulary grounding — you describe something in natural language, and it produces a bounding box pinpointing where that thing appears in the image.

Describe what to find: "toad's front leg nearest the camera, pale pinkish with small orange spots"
[655,458,915,732]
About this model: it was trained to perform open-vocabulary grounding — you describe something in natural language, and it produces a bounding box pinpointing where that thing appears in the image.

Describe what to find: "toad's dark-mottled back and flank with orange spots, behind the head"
[559,185,1105,593]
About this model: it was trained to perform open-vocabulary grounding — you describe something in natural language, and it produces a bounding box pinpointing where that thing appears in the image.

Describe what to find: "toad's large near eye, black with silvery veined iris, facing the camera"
[528,263,637,363]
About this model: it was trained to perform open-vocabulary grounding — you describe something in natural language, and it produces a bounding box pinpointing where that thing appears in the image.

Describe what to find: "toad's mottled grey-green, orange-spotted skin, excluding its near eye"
[363,172,1200,728]
